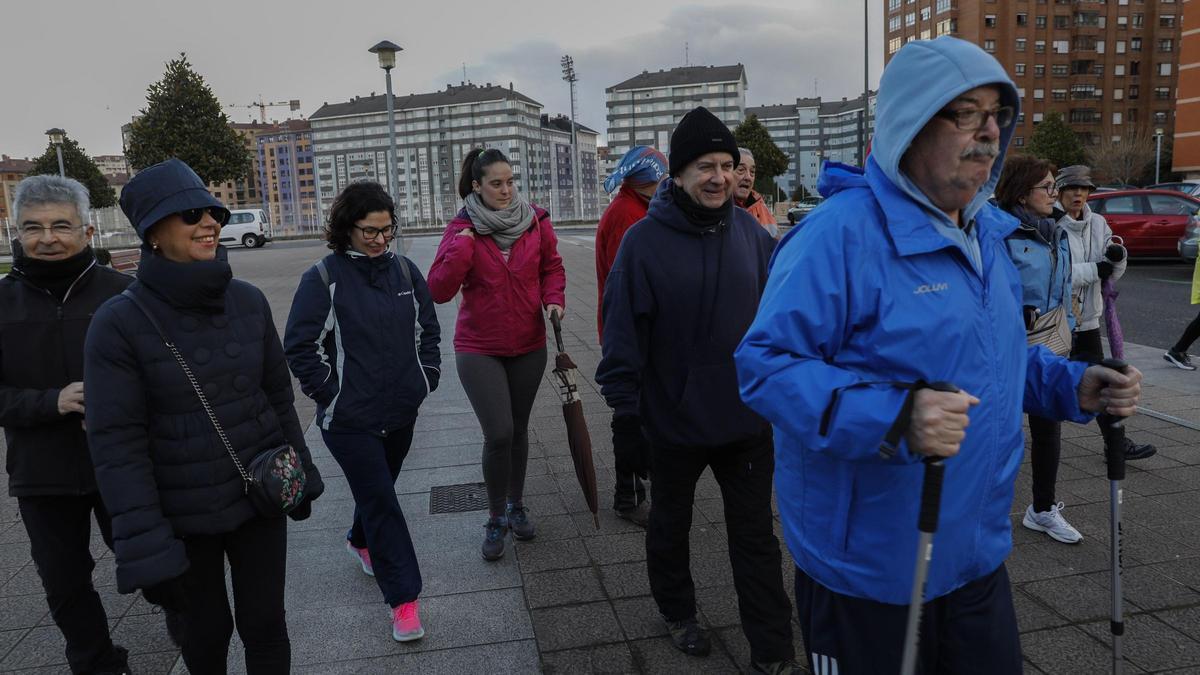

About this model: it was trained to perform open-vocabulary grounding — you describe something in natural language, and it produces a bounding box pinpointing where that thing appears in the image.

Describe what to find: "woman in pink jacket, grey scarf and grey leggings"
[428,148,566,560]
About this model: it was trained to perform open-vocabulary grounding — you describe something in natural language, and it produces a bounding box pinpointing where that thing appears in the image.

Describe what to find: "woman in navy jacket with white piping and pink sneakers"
[283,181,442,641]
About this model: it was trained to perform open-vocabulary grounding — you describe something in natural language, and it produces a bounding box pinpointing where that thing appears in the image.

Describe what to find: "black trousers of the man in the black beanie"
[646,434,794,662]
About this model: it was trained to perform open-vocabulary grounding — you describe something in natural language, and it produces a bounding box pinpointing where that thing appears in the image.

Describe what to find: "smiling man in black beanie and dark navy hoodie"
[596,108,798,673]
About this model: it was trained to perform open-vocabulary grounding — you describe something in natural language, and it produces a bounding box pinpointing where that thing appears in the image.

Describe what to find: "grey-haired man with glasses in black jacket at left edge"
[0,175,133,673]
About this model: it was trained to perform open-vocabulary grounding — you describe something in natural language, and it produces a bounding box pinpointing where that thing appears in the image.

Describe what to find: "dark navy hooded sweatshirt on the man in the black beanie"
[596,179,775,447]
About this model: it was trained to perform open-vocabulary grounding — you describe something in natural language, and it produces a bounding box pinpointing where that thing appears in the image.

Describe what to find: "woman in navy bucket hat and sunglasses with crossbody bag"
[84,159,324,674]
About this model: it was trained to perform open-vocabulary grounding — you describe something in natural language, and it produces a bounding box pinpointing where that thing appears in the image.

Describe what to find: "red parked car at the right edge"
[1087,190,1200,258]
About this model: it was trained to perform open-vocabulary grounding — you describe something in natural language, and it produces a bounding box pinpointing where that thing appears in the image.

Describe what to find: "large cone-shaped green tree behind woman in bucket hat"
[126,54,251,183]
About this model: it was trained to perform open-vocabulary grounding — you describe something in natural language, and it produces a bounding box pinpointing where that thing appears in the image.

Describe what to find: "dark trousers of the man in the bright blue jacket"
[796,564,1022,675]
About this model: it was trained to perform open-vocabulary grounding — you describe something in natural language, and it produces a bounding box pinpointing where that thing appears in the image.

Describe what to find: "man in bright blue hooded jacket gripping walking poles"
[736,37,1141,674]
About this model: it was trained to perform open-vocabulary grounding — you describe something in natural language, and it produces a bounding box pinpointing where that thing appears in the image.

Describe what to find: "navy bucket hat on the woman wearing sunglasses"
[120,157,229,241]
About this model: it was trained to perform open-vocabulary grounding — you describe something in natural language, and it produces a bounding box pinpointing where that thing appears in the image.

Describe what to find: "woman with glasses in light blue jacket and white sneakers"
[996,155,1084,544]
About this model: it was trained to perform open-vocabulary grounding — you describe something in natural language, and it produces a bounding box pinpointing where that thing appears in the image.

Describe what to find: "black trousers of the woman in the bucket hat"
[174,518,292,675]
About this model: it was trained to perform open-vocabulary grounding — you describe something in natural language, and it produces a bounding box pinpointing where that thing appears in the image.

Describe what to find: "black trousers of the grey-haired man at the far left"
[17,494,126,673]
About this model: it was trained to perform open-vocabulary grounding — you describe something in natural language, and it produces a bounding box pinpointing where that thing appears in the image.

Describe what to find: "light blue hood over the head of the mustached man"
[871,36,1020,221]
